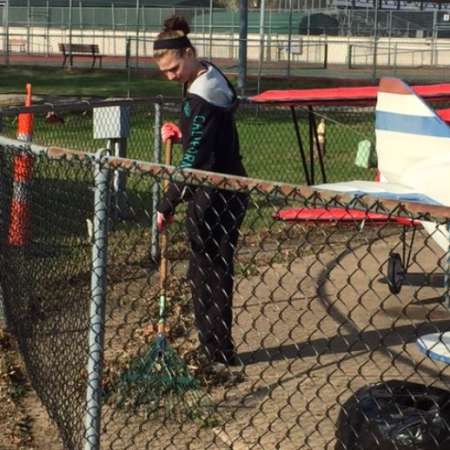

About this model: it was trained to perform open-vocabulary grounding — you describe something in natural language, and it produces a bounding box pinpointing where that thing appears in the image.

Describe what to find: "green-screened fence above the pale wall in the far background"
[0,0,449,37]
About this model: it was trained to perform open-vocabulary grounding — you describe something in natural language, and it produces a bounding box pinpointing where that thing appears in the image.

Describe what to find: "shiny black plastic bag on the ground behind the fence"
[335,380,450,450]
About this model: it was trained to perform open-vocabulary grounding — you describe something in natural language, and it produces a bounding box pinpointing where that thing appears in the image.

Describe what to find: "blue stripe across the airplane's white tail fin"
[375,111,450,137]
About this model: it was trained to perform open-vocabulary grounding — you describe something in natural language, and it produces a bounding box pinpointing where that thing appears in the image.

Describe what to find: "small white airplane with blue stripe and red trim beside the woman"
[280,78,450,293]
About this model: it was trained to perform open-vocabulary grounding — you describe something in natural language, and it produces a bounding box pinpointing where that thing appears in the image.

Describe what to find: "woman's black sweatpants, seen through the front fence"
[187,189,248,363]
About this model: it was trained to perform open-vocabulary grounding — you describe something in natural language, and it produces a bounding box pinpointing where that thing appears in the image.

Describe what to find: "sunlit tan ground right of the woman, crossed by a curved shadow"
[214,230,450,450]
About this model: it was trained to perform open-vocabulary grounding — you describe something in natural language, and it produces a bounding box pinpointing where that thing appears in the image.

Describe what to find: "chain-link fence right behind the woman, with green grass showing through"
[2,97,375,183]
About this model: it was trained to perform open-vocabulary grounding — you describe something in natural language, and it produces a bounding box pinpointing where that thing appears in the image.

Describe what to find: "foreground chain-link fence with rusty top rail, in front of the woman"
[0,103,450,449]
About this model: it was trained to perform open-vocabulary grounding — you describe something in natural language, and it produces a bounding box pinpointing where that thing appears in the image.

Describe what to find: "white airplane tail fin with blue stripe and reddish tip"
[375,78,450,183]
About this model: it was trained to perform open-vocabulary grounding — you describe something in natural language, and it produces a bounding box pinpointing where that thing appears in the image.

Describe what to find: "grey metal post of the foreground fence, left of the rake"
[84,151,109,450]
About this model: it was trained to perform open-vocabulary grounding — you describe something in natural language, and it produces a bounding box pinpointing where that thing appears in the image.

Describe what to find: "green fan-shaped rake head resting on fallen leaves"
[111,334,218,427]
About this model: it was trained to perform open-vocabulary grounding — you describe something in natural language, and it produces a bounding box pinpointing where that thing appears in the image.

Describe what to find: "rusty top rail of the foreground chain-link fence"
[0,136,450,222]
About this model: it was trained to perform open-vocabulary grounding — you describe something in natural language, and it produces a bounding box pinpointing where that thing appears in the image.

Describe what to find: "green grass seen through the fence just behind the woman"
[3,104,373,183]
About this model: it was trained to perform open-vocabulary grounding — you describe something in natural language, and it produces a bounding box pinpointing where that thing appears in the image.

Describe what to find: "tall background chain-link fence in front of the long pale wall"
[0,0,450,86]
